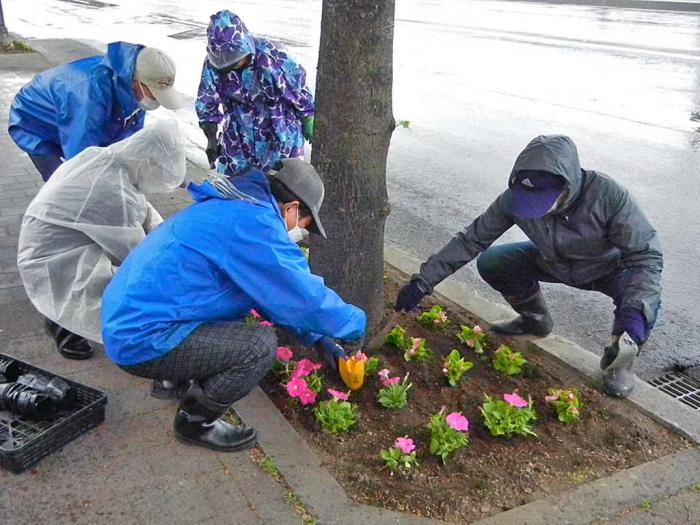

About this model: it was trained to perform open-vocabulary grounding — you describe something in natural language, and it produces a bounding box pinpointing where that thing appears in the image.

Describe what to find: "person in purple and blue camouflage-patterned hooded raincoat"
[195,10,314,176]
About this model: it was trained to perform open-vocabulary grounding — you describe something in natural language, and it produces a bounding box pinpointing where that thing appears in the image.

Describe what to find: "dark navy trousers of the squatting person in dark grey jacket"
[476,241,658,341]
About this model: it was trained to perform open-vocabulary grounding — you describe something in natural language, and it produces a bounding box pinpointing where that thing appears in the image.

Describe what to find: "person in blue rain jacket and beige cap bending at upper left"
[8,42,182,181]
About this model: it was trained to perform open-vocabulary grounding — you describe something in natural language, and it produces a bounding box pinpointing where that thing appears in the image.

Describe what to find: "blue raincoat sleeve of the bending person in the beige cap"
[56,76,112,160]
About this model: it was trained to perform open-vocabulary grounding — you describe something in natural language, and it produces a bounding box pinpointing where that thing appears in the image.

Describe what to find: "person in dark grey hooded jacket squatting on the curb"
[395,135,663,397]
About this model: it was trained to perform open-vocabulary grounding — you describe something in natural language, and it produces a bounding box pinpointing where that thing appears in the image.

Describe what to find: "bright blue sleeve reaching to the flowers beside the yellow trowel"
[208,205,367,343]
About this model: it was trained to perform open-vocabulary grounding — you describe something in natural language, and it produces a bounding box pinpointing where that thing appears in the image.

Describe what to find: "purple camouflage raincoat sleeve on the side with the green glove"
[260,51,314,119]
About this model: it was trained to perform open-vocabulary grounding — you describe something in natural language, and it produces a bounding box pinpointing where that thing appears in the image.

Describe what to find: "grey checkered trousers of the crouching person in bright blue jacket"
[121,321,277,405]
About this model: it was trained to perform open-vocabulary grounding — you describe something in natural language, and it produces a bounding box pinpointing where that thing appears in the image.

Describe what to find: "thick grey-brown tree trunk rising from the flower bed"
[311,0,395,333]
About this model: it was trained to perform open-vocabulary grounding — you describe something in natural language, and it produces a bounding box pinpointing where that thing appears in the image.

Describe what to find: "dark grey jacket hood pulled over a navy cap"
[508,135,583,210]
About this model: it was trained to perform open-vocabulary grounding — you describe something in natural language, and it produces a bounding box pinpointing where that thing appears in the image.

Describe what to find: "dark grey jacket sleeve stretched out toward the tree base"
[414,193,514,293]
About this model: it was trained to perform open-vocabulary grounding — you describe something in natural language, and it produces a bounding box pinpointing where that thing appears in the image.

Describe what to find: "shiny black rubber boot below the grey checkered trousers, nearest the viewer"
[173,383,257,452]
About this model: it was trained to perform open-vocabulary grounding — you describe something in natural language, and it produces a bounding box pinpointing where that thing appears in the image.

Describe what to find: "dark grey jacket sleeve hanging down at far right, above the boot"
[608,191,663,327]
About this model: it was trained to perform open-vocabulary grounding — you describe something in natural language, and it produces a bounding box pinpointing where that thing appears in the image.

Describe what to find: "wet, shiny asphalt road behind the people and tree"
[3,0,700,377]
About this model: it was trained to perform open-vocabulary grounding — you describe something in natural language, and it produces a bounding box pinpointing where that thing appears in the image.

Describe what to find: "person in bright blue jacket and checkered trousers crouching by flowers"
[102,159,366,451]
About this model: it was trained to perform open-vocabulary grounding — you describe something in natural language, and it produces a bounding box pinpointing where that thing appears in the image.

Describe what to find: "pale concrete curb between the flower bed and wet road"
[384,243,700,444]
